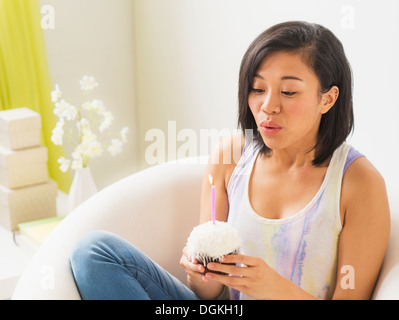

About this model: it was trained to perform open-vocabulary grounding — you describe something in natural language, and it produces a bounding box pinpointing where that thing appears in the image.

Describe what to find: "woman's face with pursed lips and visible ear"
[248,52,338,151]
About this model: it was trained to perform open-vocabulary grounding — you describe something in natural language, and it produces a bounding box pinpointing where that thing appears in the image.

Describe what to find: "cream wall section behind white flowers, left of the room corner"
[41,0,137,189]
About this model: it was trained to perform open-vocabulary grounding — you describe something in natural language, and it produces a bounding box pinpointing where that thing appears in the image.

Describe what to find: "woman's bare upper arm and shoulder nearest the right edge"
[333,157,390,299]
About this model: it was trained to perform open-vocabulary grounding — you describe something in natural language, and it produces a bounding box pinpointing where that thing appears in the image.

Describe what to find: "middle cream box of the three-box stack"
[0,146,48,189]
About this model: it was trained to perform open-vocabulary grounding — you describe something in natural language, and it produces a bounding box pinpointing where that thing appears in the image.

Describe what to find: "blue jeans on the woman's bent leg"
[70,231,198,300]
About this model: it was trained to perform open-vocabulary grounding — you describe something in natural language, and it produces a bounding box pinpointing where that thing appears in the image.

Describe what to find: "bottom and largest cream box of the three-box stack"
[0,180,57,231]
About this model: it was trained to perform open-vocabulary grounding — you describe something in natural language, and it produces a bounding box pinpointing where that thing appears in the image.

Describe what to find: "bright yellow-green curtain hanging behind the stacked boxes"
[0,0,71,192]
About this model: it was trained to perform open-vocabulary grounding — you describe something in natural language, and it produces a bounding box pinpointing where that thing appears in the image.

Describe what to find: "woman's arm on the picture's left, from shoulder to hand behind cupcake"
[180,136,245,299]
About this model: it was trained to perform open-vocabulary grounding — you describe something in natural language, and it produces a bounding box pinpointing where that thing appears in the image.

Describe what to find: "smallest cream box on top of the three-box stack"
[0,108,42,150]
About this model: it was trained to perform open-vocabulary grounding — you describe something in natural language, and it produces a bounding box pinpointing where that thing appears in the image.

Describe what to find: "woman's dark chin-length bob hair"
[238,21,354,166]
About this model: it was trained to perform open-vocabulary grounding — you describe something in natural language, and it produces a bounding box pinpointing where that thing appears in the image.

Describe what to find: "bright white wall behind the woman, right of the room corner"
[134,0,399,208]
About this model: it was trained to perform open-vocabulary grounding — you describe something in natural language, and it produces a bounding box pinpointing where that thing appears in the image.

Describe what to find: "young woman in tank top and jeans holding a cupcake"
[71,22,390,299]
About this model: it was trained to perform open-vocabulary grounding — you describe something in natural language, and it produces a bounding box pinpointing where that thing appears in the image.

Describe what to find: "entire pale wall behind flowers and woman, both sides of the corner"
[41,0,399,208]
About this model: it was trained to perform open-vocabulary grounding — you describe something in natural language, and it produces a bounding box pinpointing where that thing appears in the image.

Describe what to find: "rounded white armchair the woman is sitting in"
[13,157,399,300]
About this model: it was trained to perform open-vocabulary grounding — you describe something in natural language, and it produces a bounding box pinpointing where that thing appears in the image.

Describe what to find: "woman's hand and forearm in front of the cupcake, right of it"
[205,254,314,299]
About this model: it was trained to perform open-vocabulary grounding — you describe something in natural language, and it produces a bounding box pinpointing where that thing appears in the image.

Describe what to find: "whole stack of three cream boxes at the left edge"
[0,108,57,230]
